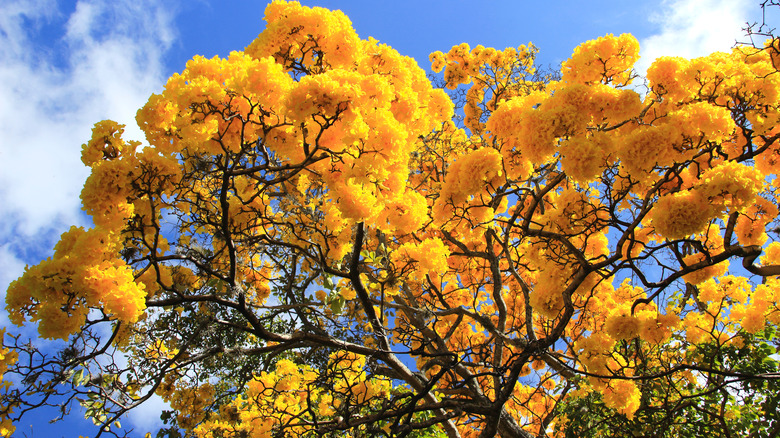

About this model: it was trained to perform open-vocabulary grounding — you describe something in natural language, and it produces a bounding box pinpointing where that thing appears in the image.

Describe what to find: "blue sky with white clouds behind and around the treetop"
[0,0,780,438]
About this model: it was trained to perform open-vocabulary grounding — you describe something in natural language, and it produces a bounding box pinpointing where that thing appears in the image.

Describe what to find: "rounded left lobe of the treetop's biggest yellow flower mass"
[136,52,293,155]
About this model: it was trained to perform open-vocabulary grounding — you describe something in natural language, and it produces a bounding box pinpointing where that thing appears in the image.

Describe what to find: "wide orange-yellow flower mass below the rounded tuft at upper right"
[486,82,644,183]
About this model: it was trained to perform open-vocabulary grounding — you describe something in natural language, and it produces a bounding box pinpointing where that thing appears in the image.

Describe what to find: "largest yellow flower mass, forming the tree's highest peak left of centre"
[138,1,453,243]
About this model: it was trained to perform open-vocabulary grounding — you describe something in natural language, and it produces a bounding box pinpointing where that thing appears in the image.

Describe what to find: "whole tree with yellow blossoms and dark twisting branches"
[0,1,780,438]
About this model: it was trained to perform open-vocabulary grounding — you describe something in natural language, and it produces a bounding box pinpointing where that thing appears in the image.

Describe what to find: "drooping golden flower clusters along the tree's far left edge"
[6,114,174,339]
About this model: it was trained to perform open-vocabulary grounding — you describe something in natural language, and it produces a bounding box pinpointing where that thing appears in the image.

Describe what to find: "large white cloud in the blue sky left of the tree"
[0,0,173,241]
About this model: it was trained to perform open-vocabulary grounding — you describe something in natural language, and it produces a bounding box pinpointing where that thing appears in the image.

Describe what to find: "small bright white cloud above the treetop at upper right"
[636,0,760,75]
